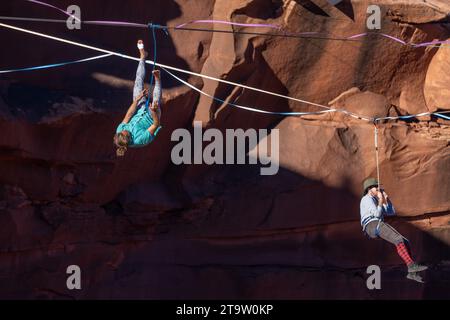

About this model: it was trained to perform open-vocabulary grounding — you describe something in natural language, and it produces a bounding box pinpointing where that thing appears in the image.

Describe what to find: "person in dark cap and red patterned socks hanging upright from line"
[360,178,428,278]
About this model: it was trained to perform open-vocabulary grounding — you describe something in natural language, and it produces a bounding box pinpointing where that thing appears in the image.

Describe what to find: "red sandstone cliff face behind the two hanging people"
[0,0,450,299]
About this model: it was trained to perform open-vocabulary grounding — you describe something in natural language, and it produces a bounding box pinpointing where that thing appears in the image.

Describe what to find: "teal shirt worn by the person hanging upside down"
[116,104,161,148]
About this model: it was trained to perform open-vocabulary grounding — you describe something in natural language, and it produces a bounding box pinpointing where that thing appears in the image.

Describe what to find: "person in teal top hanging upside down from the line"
[114,40,161,157]
